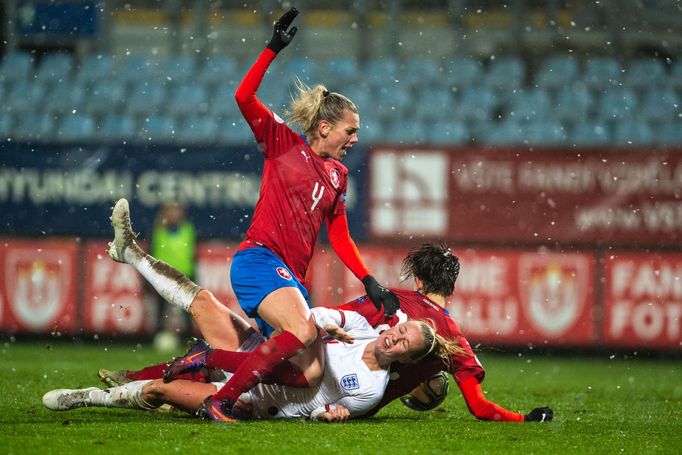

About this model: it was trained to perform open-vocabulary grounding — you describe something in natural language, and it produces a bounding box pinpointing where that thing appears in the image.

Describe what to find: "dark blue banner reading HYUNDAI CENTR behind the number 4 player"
[0,142,367,240]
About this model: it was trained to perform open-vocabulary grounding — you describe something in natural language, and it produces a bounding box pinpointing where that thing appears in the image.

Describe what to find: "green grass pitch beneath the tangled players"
[0,342,682,455]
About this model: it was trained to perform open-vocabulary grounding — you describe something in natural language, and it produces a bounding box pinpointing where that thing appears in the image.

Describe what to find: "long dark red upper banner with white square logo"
[369,148,682,246]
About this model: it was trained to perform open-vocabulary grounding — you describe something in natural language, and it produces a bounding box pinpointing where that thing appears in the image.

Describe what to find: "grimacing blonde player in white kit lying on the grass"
[43,308,456,422]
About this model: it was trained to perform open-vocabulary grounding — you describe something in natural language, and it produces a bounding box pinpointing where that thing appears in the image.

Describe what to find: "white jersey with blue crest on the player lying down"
[239,307,389,419]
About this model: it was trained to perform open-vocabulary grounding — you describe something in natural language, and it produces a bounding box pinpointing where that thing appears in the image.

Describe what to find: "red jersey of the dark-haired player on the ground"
[338,289,485,417]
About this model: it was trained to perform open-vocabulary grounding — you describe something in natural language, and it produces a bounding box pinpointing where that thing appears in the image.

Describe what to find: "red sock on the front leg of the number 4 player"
[213,332,305,402]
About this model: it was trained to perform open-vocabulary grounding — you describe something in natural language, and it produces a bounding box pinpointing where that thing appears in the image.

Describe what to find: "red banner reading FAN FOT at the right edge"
[603,252,682,350]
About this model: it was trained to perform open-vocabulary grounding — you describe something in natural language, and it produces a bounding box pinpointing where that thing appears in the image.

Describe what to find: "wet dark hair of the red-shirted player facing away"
[401,243,459,297]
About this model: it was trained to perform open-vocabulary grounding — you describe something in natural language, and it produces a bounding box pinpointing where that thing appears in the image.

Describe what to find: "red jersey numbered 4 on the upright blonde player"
[235,49,348,283]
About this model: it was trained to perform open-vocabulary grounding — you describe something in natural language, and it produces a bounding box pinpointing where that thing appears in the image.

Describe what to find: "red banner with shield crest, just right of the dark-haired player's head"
[448,250,596,346]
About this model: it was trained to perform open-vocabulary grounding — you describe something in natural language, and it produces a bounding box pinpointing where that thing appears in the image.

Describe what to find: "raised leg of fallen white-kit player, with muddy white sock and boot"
[107,199,256,350]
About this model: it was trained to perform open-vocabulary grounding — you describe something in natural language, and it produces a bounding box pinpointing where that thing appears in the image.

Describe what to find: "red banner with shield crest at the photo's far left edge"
[0,240,78,334]
